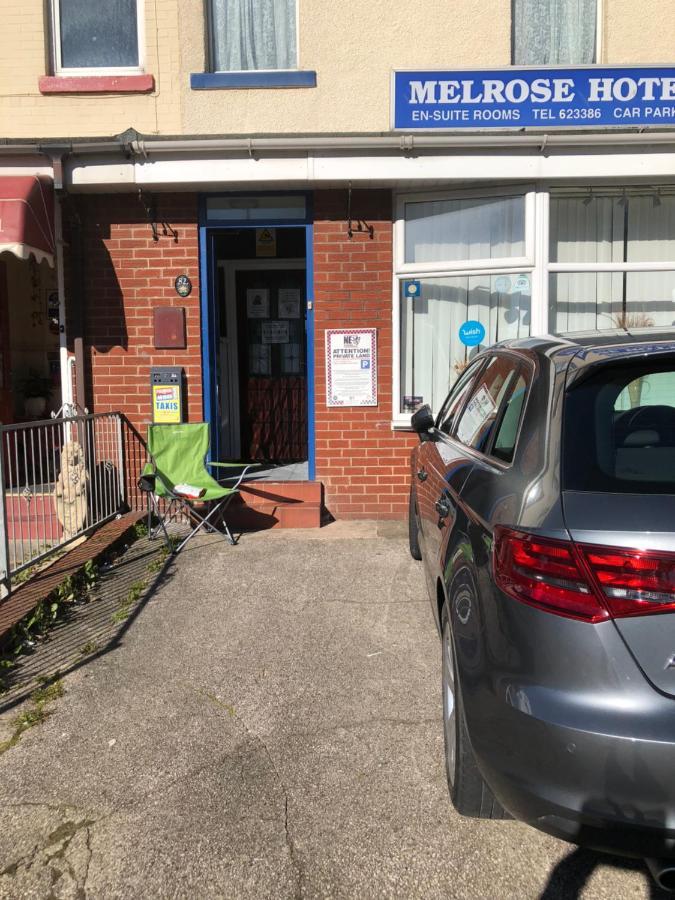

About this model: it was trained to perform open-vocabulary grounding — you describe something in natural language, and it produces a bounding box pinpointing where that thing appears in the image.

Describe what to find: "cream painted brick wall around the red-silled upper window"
[0,0,180,138]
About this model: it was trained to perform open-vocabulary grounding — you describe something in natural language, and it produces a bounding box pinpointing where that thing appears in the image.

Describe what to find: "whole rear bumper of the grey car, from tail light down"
[455,597,675,857]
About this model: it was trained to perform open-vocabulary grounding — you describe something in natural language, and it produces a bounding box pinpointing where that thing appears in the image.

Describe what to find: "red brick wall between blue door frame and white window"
[314,190,417,519]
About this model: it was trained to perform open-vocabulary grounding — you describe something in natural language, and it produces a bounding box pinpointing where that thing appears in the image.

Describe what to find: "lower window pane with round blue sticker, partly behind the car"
[400,274,531,412]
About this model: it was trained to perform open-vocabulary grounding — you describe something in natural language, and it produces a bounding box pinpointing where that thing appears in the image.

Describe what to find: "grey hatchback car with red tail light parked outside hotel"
[410,328,675,888]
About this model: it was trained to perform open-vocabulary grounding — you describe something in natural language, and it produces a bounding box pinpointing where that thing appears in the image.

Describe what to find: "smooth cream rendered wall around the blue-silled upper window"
[180,0,511,134]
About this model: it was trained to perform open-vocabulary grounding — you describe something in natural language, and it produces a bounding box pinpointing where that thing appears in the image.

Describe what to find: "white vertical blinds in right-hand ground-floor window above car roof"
[549,189,675,333]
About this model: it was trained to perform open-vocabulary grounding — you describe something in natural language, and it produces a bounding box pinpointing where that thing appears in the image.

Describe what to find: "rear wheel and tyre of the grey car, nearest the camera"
[441,604,508,819]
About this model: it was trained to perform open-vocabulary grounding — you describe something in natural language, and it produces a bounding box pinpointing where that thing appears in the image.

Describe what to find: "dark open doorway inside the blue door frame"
[214,227,308,481]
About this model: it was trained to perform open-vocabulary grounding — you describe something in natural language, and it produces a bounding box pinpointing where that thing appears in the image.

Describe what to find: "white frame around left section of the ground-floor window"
[391,184,548,430]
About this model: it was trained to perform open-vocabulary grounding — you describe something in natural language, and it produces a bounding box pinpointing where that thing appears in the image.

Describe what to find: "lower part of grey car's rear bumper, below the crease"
[472,709,675,856]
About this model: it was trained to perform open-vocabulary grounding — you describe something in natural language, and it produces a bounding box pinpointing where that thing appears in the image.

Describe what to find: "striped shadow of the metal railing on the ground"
[0,537,177,713]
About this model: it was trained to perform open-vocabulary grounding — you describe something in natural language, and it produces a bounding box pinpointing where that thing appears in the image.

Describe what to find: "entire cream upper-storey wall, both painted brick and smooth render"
[0,0,675,138]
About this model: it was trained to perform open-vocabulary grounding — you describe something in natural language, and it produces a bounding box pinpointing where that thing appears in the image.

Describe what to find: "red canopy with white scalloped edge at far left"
[0,175,54,266]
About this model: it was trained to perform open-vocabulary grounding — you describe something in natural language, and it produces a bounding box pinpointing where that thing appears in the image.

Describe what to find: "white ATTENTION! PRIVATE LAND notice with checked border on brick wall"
[326,328,377,406]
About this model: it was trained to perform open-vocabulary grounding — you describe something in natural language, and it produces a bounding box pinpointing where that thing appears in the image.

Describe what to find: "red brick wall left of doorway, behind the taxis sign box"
[68,194,203,435]
